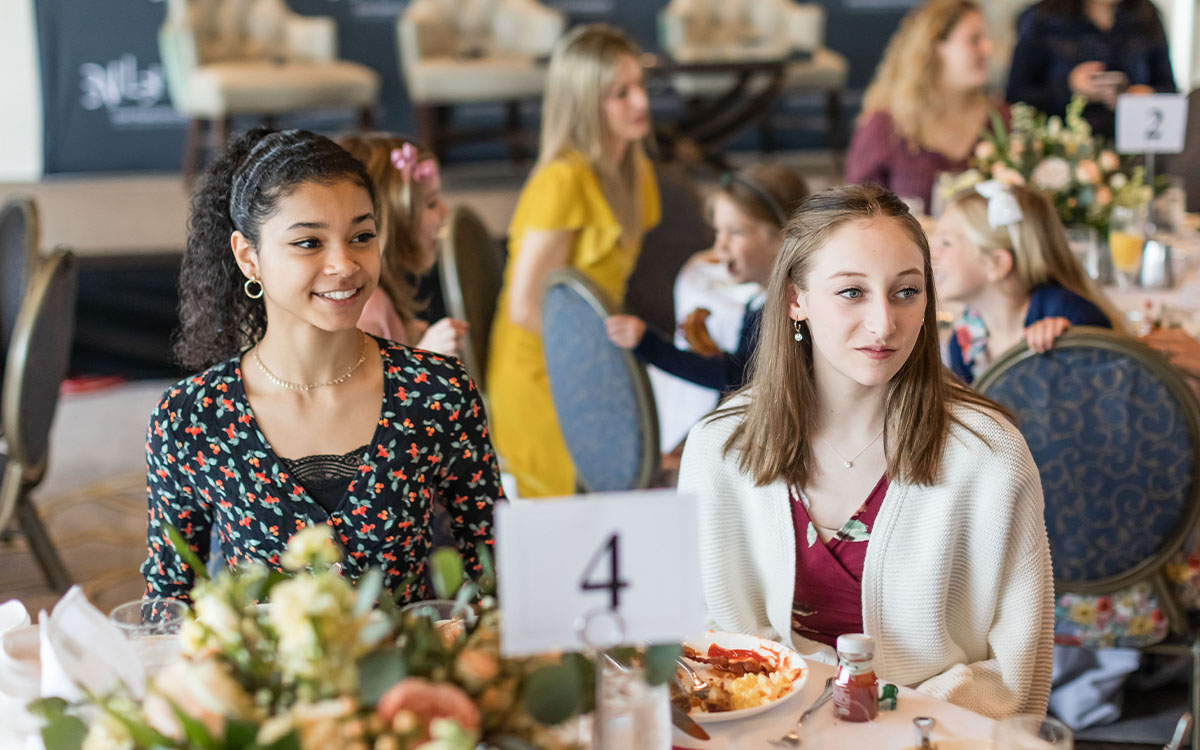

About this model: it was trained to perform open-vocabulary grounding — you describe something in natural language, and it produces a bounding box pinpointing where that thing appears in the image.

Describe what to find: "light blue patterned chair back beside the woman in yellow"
[541,269,660,492]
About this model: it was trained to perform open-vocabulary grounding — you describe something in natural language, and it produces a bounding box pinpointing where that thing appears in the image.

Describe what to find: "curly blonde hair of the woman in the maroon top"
[859,0,988,148]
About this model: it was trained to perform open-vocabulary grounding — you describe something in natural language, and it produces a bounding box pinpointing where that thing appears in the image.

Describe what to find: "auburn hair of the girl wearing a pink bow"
[337,133,436,326]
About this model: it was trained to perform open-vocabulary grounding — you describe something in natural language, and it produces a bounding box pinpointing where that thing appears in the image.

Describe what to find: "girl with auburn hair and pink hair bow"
[338,133,467,356]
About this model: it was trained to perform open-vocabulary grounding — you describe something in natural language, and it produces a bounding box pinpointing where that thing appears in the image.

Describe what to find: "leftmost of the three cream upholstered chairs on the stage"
[158,0,379,174]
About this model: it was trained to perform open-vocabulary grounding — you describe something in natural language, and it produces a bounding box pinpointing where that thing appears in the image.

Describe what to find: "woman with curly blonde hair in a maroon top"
[846,0,1008,208]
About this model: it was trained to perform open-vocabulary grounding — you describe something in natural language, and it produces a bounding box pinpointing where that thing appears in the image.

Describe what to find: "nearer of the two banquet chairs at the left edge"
[0,248,78,592]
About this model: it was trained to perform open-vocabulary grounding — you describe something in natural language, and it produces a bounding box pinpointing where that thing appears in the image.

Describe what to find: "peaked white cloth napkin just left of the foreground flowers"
[38,586,145,701]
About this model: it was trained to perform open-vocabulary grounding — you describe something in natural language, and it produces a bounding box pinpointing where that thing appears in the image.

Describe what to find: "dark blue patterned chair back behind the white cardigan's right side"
[976,328,1200,593]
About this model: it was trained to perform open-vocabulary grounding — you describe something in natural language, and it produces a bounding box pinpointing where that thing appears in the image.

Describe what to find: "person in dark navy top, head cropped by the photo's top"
[1007,0,1175,138]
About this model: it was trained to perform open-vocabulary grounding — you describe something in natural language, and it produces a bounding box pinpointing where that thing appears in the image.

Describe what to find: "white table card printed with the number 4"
[496,490,704,656]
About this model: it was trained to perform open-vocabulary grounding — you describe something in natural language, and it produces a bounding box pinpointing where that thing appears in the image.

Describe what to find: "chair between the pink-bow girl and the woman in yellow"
[438,205,504,394]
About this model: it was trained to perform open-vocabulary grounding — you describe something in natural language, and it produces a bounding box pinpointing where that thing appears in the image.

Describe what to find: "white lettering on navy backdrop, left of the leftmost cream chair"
[79,54,184,127]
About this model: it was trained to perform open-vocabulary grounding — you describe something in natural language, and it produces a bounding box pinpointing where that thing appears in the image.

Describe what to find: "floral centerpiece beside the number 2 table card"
[940,97,1152,234]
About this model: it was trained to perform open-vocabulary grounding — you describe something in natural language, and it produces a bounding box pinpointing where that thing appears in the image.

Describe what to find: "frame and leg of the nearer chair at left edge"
[0,248,76,590]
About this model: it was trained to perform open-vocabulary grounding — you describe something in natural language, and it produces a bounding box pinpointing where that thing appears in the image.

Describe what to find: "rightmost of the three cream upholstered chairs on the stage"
[659,0,850,149]
